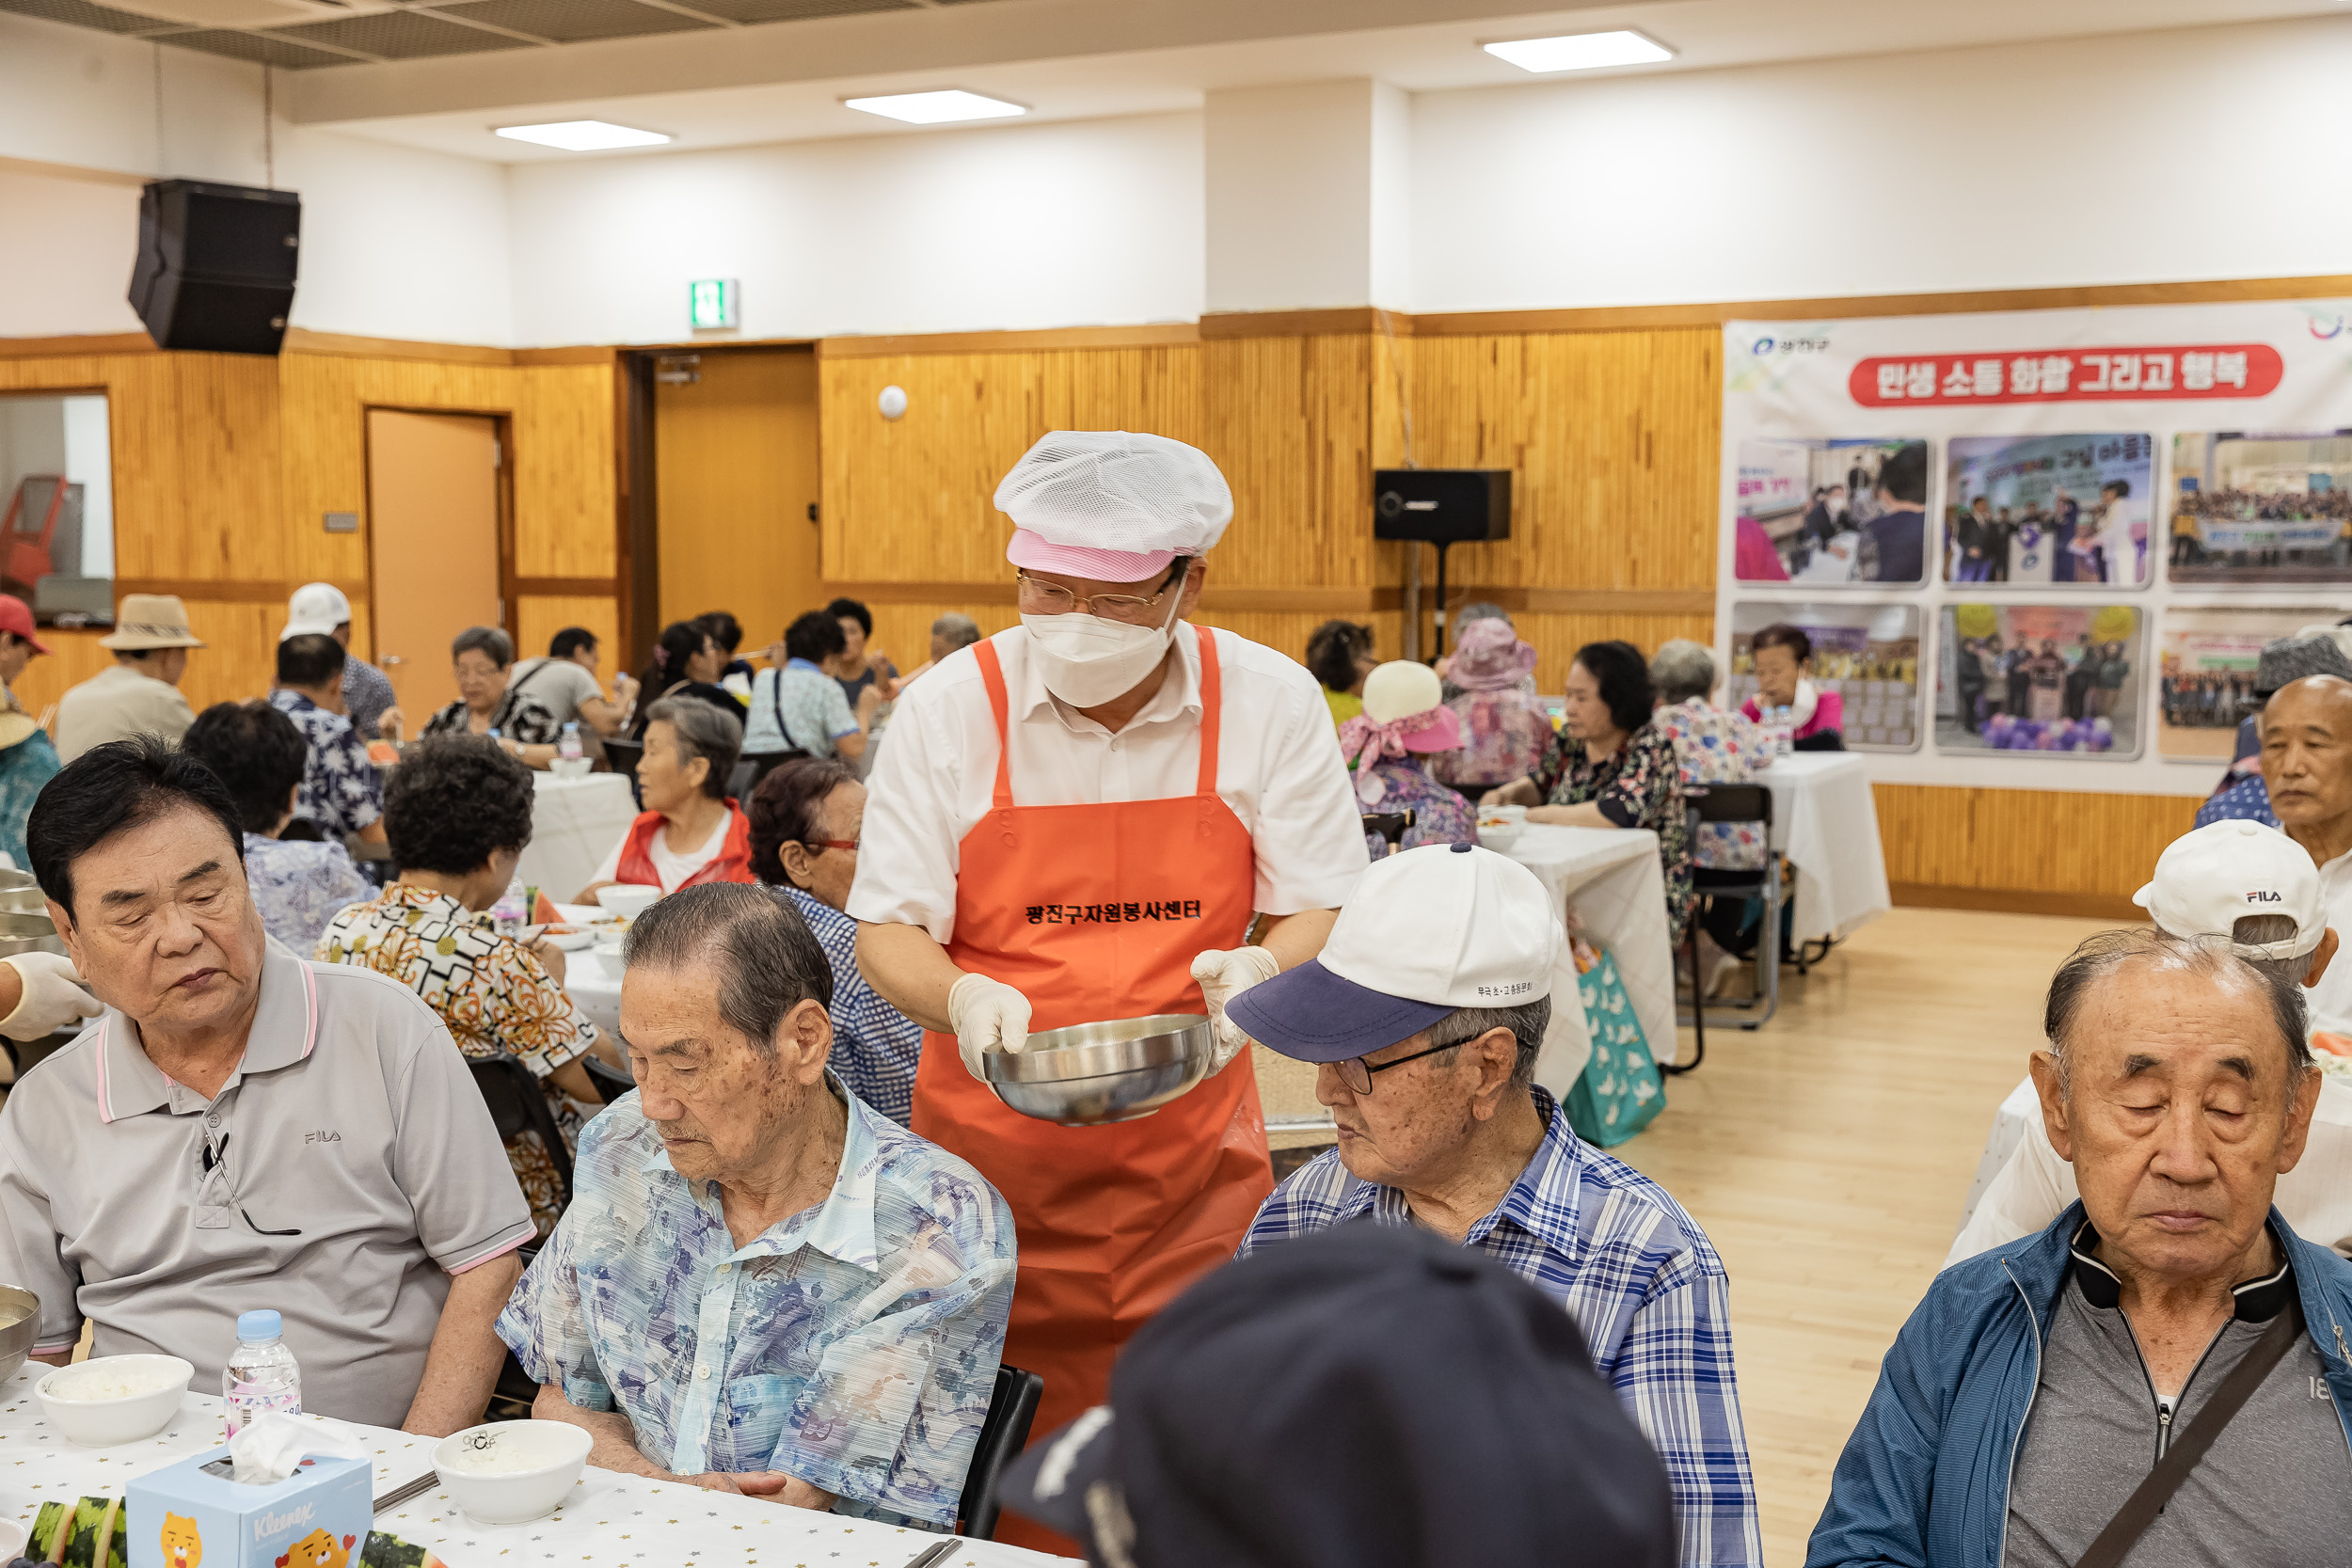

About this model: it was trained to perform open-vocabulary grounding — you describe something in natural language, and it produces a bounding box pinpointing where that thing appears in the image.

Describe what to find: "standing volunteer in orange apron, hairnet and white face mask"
[850,430,1367,1540]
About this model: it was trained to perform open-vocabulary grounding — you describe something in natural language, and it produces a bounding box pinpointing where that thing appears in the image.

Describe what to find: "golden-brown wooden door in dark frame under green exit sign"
[654,348,826,656]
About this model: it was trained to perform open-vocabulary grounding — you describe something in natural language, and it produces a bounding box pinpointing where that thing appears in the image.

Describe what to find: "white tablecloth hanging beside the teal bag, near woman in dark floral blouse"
[1503,823,1675,1063]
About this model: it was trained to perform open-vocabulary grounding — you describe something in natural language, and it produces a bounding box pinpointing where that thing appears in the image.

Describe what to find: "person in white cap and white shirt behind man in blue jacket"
[1943,818,2352,1267]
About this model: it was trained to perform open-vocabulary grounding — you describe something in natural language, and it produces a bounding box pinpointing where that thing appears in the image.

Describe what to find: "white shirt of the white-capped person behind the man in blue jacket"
[1946,1074,2352,1267]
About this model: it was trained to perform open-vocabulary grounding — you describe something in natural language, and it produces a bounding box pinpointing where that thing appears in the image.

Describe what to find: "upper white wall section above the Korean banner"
[1411,16,2352,310]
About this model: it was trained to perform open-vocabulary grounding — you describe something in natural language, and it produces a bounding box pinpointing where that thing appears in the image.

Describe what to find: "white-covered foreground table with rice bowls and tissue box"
[0,1382,1071,1568]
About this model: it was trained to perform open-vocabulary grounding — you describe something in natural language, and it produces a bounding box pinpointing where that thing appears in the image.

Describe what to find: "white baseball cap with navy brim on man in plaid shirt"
[1228,844,1569,1063]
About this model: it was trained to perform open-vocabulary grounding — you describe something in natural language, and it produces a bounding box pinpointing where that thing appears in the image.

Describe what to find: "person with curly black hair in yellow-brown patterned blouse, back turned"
[318,736,605,1239]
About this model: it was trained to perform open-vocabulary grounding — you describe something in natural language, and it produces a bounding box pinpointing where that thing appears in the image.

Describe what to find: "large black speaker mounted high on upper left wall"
[132,179,301,355]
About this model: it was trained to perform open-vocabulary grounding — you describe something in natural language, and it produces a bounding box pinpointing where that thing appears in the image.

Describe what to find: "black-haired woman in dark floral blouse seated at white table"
[1485,641,1693,945]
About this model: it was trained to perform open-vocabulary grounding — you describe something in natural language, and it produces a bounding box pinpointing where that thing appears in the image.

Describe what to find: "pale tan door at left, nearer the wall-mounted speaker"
[367,409,506,719]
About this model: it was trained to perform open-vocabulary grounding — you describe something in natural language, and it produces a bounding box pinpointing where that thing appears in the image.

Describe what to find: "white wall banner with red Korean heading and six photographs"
[1715,301,2352,795]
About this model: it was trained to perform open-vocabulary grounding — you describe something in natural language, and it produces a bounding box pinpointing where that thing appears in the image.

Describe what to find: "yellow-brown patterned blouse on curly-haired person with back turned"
[318,881,596,1239]
